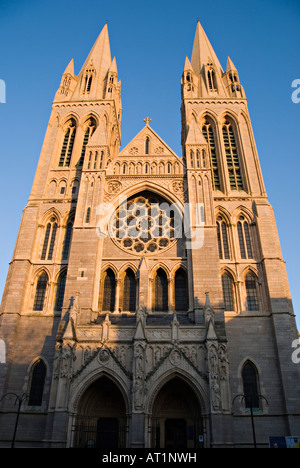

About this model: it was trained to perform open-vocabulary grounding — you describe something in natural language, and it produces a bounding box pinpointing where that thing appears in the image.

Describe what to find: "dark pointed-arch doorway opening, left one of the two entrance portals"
[73,377,127,449]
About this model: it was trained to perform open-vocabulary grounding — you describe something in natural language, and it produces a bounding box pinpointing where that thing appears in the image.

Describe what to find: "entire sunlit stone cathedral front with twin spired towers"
[0,22,300,449]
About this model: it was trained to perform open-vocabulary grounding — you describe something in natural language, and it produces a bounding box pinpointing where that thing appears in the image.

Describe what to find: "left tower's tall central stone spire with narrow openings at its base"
[73,24,112,100]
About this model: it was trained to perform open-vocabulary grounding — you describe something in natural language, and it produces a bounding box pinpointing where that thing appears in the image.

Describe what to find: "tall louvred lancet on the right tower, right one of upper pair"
[223,120,244,190]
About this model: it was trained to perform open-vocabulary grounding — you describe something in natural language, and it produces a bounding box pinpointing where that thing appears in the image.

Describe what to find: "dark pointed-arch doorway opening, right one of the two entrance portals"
[150,377,203,450]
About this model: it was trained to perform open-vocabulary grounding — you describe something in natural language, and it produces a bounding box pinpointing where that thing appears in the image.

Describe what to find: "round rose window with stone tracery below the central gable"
[110,191,181,255]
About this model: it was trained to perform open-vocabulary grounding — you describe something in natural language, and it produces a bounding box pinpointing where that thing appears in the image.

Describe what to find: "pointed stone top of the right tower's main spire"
[191,20,223,75]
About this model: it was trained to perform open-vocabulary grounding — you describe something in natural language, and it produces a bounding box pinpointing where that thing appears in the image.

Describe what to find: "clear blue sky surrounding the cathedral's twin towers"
[0,0,300,327]
